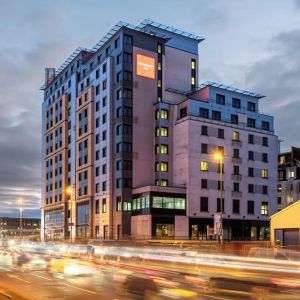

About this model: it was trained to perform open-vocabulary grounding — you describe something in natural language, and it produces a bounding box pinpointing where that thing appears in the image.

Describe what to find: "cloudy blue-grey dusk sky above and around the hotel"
[0,0,300,217]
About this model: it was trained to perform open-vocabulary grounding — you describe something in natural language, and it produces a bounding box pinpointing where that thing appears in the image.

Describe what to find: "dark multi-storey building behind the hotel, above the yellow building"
[277,147,300,210]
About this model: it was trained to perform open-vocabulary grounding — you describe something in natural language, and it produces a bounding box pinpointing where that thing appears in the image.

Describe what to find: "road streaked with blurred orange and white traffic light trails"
[0,246,300,300]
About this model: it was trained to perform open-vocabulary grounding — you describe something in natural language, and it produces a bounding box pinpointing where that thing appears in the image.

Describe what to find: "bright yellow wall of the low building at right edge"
[270,201,300,245]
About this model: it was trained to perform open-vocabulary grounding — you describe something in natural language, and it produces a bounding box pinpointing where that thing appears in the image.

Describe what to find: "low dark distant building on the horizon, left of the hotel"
[0,217,41,237]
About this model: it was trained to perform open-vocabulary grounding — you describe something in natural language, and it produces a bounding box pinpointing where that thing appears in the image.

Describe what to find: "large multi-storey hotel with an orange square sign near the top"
[42,20,277,239]
